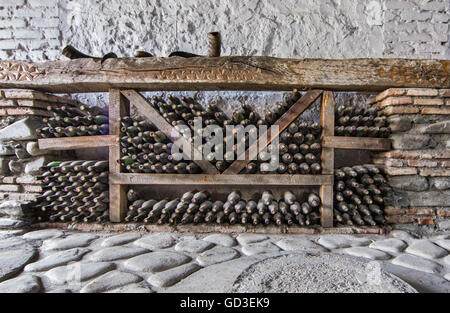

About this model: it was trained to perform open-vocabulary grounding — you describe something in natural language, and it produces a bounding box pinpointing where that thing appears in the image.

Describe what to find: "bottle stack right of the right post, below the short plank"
[334,165,391,226]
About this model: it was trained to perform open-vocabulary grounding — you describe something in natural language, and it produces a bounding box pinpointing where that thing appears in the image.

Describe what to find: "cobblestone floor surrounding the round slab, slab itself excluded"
[0,223,450,293]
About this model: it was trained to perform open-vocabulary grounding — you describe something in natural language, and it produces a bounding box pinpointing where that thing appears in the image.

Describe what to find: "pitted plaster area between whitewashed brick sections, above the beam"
[60,0,383,58]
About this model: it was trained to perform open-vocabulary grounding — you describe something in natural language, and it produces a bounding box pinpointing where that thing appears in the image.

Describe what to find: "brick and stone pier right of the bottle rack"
[369,89,450,230]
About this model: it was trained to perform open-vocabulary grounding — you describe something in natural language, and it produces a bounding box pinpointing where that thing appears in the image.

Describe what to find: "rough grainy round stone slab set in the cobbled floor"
[233,253,416,293]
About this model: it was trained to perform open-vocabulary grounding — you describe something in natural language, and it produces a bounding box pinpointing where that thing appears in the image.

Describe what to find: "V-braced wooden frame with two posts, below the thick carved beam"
[110,86,334,227]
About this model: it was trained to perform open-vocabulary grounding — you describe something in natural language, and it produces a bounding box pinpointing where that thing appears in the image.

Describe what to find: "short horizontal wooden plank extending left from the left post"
[38,135,118,150]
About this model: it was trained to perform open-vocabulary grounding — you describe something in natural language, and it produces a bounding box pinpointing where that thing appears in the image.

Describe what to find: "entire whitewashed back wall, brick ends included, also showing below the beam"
[0,0,450,109]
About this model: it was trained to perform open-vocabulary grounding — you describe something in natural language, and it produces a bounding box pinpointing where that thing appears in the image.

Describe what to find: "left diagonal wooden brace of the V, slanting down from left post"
[122,90,219,174]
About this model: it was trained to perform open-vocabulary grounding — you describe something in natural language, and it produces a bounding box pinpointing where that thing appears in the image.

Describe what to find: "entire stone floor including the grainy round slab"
[0,228,450,293]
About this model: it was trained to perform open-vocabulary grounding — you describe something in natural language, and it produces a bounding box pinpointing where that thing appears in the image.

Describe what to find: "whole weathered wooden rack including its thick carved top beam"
[0,56,434,227]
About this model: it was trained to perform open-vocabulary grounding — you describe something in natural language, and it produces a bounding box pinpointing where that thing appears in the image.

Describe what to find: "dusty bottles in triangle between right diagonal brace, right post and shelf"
[243,122,322,174]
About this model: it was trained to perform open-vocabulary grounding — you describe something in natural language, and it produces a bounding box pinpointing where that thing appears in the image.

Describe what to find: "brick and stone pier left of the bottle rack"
[0,89,78,216]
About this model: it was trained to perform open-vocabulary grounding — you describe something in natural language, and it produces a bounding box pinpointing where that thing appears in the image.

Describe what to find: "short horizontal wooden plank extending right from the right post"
[322,136,391,151]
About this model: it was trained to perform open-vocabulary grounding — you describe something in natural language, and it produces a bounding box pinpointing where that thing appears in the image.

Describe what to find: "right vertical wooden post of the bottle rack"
[320,91,334,227]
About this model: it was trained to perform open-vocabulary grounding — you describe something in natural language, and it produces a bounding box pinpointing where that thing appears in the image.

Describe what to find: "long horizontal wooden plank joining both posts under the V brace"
[109,173,333,186]
